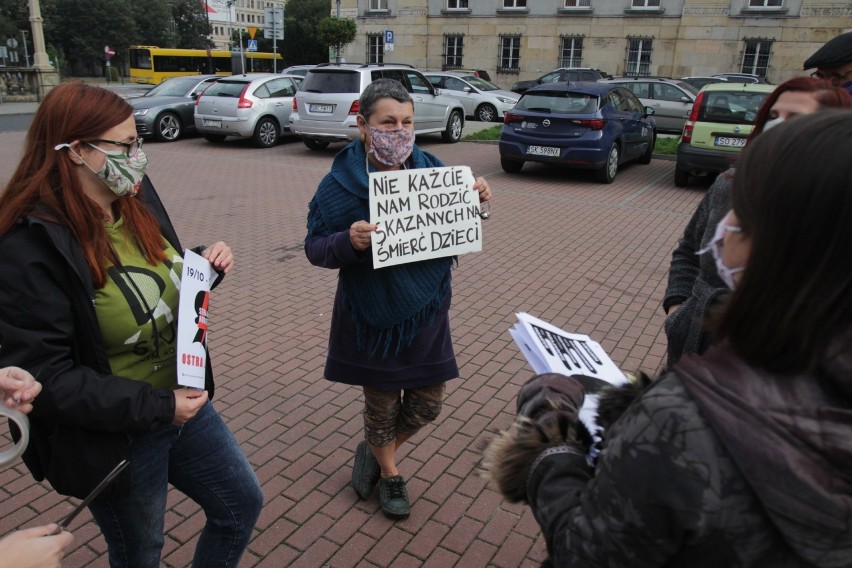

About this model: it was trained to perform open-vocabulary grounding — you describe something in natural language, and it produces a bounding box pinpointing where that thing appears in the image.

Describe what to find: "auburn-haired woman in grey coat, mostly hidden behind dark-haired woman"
[663,77,852,366]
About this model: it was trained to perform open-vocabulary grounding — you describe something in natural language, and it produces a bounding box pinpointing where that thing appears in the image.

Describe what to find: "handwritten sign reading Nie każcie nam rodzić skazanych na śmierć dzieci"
[369,166,482,268]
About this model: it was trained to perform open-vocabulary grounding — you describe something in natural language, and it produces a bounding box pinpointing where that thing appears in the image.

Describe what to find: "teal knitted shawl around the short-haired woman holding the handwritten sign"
[308,140,454,359]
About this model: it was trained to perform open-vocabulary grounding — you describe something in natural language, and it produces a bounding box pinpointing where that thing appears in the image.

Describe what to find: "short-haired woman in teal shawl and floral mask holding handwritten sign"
[305,79,491,519]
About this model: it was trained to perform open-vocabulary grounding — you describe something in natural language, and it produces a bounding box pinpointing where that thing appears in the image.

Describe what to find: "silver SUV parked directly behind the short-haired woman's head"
[290,63,465,150]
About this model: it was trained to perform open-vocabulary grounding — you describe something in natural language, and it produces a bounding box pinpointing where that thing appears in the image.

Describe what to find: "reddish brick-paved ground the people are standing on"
[0,132,703,568]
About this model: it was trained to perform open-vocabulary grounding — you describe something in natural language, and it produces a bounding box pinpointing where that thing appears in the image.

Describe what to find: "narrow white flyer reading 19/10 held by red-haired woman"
[177,249,213,389]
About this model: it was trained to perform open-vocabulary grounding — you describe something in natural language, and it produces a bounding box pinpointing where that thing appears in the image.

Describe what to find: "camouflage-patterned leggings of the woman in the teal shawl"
[364,383,445,446]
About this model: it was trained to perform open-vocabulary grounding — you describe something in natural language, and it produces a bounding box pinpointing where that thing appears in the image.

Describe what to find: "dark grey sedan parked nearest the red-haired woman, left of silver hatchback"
[127,75,221,142]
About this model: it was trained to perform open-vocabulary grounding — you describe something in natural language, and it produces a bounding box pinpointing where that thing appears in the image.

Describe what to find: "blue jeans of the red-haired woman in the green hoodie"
[89,402,263,568]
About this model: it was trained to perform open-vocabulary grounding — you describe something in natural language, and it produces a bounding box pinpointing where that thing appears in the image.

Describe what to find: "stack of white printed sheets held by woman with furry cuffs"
[509,312,628,458]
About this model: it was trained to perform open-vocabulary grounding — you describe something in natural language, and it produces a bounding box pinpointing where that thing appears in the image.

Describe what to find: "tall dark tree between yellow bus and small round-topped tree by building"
[278,0,338,66]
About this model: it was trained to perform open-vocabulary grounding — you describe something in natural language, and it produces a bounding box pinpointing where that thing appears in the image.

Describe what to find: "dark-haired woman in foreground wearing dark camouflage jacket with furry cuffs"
[484,110,852,568]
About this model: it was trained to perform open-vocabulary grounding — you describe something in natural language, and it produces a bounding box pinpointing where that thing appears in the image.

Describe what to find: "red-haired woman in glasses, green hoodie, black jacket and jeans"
[0,83,263,567]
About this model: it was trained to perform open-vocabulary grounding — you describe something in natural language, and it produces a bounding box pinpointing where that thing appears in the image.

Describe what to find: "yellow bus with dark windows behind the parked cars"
[129,45,284,85]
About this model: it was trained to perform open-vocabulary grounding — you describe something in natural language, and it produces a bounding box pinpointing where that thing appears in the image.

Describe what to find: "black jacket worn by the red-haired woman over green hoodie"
[0,177,213,498]
